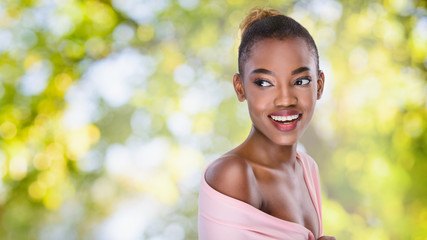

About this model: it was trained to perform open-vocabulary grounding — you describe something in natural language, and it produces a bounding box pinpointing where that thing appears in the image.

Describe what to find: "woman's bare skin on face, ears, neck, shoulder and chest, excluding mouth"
[205,38,335,240]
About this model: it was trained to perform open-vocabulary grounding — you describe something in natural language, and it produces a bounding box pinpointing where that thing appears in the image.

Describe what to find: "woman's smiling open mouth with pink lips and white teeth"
[268,110,302,132]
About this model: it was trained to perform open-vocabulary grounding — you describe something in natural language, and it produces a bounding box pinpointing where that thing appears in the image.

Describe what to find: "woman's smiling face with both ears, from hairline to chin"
[233,38,324,145]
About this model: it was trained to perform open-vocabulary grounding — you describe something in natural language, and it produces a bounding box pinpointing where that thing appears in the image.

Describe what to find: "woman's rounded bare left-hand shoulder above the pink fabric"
[205,154,261,208]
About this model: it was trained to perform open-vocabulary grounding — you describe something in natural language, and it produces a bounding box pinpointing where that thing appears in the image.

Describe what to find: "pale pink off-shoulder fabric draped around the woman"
[198,152,323,240]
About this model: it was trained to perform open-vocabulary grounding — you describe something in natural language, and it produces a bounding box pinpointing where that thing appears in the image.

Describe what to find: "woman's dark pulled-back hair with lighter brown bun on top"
[238,9,319,74]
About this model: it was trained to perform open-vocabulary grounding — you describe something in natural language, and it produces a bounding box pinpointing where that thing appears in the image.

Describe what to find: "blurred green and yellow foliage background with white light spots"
[0,0,427,240]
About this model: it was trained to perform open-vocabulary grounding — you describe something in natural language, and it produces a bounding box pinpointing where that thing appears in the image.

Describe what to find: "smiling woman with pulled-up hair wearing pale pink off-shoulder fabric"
[199,9,334,240]
